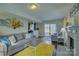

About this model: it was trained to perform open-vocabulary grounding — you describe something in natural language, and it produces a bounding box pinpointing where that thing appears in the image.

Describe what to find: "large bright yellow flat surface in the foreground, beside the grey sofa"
[15,43,55,56]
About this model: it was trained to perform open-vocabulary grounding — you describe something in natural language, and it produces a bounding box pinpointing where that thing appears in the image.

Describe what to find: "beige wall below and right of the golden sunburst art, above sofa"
[0,20,28,35]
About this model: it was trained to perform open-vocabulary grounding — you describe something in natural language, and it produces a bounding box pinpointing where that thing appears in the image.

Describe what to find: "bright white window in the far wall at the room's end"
[44,24,56,36]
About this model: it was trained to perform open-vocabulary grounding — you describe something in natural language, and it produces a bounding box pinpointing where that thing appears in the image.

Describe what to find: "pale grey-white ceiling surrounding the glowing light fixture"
[0,3,73,22]
